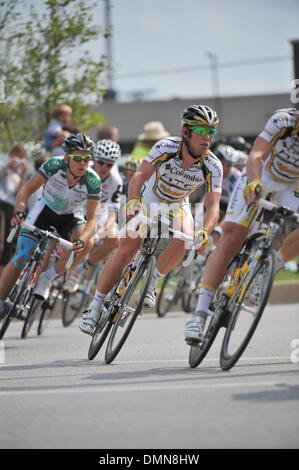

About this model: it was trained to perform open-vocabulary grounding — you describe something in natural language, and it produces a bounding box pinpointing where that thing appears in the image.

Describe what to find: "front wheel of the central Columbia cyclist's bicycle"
[105,256,156,364]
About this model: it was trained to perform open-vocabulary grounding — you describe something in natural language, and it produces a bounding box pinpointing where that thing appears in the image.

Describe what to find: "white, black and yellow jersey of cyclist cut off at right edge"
[260,108,299,183]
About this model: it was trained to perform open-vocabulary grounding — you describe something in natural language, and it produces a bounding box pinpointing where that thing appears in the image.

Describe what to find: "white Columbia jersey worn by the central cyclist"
[142,137,223,203]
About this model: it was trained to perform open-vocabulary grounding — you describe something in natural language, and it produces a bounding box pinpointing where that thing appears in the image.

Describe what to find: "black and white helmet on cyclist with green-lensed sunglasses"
[181,104,219,127]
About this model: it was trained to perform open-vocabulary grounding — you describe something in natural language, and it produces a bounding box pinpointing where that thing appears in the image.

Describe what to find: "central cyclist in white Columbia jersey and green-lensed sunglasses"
[80,105,222,334]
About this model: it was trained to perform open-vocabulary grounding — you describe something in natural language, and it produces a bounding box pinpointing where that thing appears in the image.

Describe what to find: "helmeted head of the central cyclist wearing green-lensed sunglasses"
[181,104,219,159]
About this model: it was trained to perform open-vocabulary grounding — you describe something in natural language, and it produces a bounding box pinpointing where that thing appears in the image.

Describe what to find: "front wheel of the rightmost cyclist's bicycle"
[220,251,275,370]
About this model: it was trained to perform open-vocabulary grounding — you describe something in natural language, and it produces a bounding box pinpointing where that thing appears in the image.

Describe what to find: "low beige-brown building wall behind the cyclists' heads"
[98,94,293,143]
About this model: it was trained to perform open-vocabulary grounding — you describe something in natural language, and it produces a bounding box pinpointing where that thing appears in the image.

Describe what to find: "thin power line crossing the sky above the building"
[115,56,292,80]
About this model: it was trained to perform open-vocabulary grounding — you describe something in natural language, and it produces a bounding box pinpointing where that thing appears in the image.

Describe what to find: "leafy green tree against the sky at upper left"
[0,0,106,150]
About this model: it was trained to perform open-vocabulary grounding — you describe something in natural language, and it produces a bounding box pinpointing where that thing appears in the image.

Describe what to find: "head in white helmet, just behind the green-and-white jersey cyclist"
[92,139,121,178]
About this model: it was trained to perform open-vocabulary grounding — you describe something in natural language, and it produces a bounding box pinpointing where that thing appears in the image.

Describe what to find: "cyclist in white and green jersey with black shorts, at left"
[0,134,102,316]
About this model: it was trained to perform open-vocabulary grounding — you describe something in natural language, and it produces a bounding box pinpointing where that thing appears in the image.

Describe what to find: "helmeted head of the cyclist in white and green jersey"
[63,133,94,179]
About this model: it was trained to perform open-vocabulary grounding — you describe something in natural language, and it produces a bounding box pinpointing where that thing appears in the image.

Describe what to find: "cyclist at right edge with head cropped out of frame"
[185,108,299,341]
